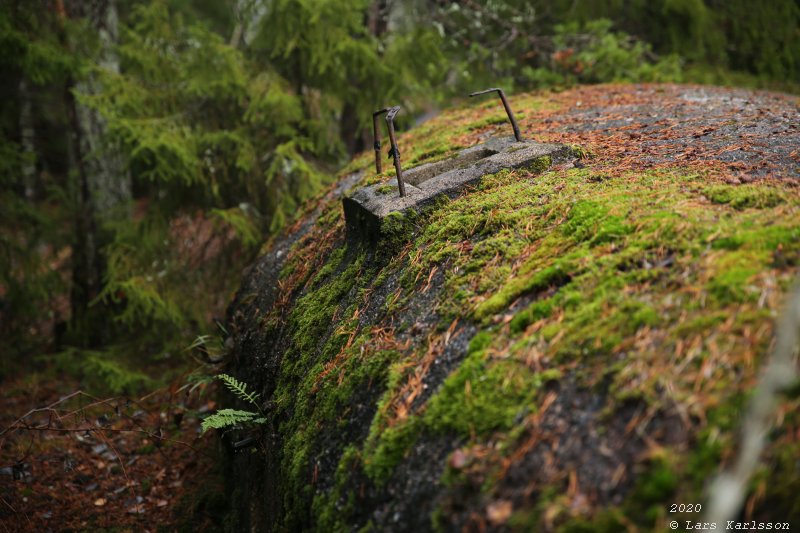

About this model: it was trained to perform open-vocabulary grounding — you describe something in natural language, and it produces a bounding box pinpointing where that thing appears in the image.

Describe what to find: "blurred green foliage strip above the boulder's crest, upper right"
[422,0,800,91]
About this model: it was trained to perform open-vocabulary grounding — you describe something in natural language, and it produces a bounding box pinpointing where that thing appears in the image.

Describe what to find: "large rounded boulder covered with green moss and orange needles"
[220,86,800,531]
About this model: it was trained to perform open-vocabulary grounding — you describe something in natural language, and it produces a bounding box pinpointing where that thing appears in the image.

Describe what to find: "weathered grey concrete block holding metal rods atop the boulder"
[342,137,573,242]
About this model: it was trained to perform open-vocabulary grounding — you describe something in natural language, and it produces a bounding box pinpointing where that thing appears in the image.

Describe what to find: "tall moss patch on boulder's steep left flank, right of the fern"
[268,240,398,528]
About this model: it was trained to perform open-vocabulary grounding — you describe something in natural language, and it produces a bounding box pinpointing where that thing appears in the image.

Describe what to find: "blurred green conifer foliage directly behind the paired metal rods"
[253,0,447,156]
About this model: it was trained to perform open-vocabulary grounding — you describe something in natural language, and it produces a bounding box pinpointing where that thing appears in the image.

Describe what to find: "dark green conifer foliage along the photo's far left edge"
[0,2,76,370]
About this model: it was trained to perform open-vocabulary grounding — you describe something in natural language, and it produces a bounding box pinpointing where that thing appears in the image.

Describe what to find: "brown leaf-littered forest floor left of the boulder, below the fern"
[0,374,226,532]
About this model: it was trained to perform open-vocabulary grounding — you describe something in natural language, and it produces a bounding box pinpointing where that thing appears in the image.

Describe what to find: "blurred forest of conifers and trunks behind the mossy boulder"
[0,0,800,393]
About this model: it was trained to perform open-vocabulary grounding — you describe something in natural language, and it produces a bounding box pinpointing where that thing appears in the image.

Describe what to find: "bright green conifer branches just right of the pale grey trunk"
[84,3,321,227]
